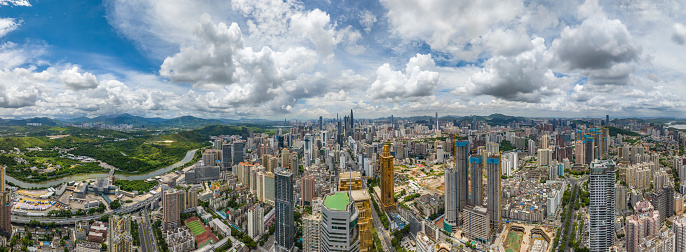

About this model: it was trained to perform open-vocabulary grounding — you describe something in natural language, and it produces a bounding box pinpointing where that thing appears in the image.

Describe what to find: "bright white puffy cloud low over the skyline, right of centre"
[367,54,439,100]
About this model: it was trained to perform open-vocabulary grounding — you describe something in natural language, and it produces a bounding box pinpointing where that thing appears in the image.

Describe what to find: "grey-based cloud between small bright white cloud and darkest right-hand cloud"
[470,38,563,102]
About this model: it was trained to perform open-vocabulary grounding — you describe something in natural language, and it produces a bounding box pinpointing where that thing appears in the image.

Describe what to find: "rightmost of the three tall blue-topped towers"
[486,155,501,231]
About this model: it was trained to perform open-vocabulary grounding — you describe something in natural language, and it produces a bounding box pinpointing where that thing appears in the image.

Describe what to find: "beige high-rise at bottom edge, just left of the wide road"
[107,214,134,252]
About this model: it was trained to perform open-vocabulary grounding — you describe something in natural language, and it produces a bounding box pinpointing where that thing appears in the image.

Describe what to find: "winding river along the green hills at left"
[6,149,198,188]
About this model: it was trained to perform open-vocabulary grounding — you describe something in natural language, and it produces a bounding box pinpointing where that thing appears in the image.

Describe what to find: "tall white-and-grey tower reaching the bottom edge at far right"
[589,160,615,252]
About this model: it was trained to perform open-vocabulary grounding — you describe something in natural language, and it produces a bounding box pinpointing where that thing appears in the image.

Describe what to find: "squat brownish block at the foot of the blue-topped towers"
[462,205,491,244]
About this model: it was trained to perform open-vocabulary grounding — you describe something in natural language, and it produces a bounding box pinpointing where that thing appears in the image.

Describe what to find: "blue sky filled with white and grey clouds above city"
[0,0,686,120]
